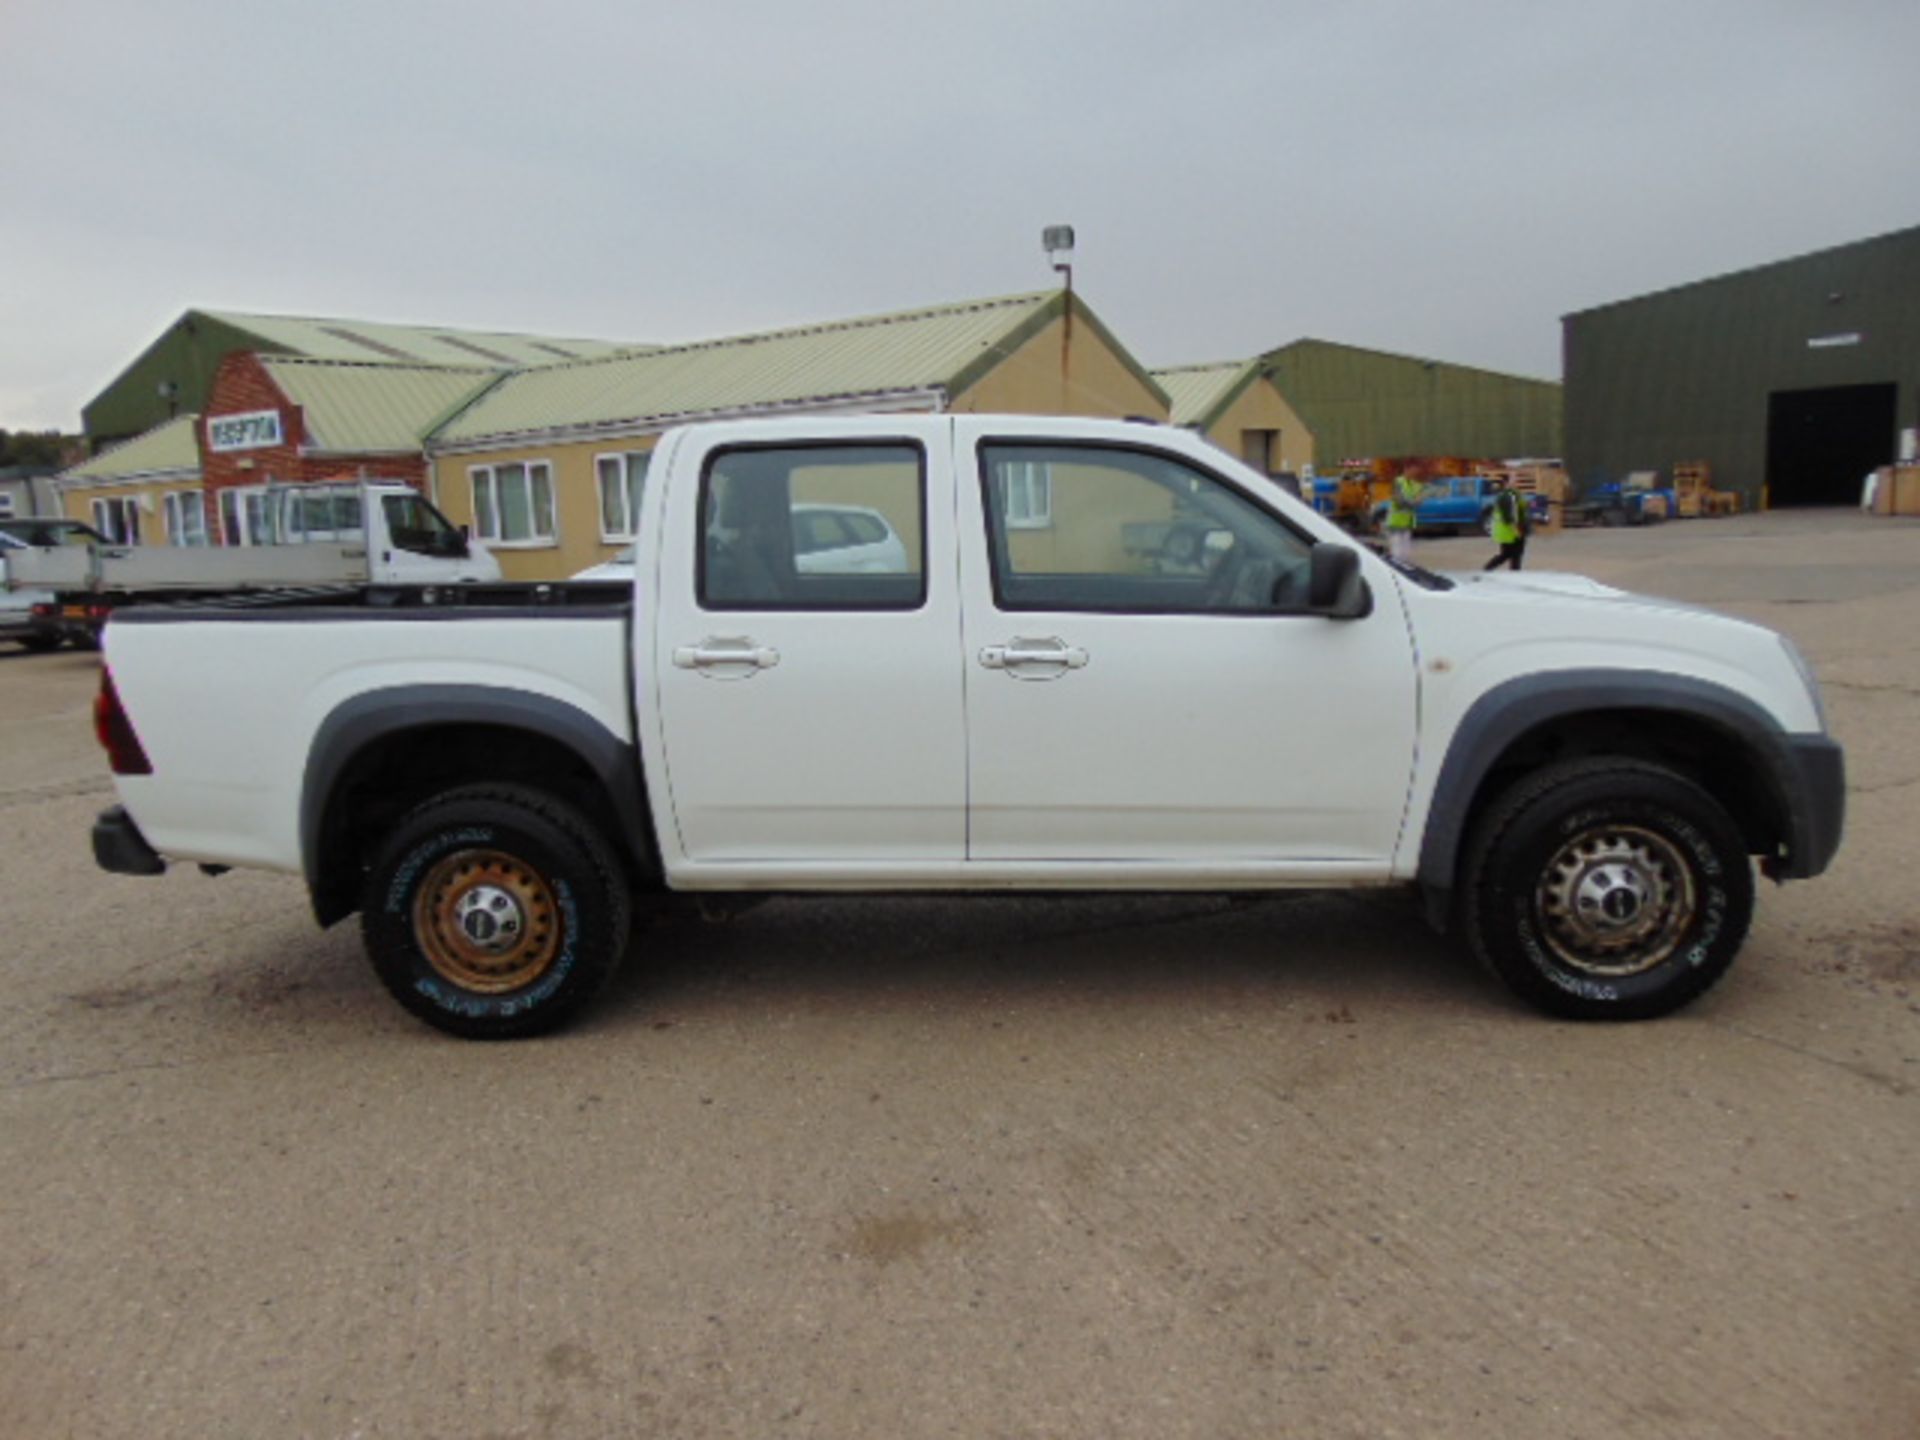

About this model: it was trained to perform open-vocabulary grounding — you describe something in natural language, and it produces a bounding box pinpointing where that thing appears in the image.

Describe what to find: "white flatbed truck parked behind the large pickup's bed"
[0,480,499,643]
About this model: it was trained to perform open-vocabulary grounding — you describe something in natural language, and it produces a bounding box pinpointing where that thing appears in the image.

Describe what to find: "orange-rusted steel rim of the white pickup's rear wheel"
[413,851,564,995]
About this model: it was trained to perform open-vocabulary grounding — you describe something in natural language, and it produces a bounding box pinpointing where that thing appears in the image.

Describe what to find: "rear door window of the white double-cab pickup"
[699,444,927,611]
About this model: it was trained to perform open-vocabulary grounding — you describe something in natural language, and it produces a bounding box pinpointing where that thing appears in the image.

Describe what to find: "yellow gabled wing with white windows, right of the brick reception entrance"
[426,290,1169,580]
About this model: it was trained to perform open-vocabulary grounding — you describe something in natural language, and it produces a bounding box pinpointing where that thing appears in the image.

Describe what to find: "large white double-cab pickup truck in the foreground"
[94,415,1843,1037]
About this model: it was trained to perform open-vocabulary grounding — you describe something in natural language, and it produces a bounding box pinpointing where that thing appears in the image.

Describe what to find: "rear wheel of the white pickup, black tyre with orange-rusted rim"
[361,785,630,1041]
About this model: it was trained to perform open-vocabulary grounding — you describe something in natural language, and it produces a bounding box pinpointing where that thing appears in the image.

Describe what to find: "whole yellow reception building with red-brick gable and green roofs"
[58,290,1169,580]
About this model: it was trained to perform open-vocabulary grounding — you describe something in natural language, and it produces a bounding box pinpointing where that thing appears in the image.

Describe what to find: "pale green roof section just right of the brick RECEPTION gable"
[261,355,499,455]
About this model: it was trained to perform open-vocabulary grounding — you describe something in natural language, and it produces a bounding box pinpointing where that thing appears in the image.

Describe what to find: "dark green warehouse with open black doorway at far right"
[1561,227,1920,507]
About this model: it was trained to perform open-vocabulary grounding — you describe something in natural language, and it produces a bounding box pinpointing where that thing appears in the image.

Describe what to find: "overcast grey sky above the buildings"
[0,0,1920,428]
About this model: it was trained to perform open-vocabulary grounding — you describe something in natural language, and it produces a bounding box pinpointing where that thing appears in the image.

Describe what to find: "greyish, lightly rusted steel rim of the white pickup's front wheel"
[1534,826,1697,979]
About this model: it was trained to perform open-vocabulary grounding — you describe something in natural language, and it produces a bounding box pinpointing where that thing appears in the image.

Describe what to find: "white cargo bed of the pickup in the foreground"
[106,584,634,872]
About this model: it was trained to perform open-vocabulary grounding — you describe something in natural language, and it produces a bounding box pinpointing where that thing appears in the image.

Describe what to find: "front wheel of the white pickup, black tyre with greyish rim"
[1459,758,1753,1020]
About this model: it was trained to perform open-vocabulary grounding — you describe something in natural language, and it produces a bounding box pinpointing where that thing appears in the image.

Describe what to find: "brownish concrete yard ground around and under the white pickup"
[0,513,1920,1440]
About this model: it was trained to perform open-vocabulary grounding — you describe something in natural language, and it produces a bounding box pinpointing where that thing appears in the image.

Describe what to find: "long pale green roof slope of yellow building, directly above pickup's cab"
[434,290,1085,445]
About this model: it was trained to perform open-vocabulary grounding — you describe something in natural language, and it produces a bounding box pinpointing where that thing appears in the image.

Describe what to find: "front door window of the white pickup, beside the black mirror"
[981,444,1311,614]
